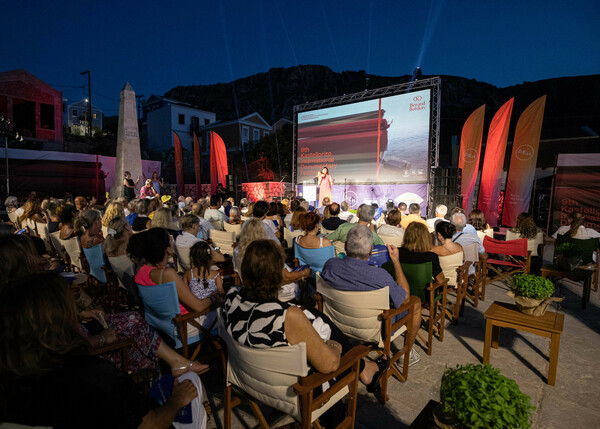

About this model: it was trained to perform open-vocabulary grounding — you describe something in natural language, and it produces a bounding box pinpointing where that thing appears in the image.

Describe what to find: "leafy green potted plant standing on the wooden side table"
[508,274,563,316]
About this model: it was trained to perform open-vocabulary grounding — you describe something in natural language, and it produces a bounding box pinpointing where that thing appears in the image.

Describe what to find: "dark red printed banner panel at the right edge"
[548,153,600,234]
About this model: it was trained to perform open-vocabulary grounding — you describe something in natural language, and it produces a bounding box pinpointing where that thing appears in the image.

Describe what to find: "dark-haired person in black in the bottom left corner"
[0,273,205,427]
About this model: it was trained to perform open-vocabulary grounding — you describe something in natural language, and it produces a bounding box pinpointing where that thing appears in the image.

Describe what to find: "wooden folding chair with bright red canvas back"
[483,236,531,281]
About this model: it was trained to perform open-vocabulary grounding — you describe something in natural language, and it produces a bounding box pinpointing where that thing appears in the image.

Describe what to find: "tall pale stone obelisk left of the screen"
[110,82,144,198]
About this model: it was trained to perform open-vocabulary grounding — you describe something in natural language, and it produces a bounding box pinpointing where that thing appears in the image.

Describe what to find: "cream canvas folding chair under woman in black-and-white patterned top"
[218,315,369,429]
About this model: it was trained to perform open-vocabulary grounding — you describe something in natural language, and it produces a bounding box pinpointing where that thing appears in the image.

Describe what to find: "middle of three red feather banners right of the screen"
[477,97,515,227]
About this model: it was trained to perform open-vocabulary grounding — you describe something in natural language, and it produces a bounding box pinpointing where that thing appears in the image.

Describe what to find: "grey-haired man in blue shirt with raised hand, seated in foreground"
[321,225,421,365]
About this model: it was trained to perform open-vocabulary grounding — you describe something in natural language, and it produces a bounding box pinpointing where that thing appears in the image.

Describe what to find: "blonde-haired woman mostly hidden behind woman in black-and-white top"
[233,218,310,301]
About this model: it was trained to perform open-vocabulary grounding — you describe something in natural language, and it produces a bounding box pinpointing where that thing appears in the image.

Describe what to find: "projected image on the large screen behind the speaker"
[297,89,431,184]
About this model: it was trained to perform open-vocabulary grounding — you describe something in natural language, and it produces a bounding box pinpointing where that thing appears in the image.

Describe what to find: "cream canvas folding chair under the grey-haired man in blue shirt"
[315,273,420,404]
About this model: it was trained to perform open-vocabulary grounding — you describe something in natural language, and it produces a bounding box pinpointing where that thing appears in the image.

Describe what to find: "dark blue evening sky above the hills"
[0,0,600,115]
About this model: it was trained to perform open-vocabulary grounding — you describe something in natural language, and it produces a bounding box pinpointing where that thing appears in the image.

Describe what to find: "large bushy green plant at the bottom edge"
[434,364,535,429]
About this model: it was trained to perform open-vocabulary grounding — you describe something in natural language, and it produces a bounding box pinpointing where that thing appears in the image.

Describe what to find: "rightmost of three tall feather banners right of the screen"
[502,95,546,226]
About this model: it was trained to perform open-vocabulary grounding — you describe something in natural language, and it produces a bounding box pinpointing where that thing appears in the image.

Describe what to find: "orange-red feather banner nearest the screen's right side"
[458,104,485,214]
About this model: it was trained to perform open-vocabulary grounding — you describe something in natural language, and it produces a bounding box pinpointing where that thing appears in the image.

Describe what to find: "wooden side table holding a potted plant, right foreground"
[483,301,565,386]
